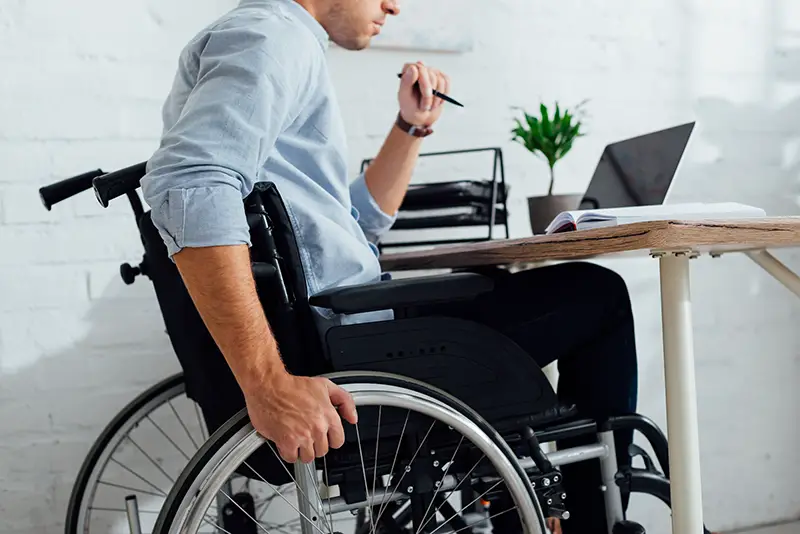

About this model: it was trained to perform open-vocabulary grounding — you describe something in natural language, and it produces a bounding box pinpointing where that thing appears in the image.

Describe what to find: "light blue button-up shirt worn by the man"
[142,0,394,322]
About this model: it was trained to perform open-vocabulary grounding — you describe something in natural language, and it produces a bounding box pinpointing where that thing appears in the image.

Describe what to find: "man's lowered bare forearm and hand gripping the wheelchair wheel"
[174,245,357,463]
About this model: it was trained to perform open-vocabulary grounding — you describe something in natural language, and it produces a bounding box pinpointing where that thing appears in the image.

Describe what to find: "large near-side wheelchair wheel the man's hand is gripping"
[153,373,546,534]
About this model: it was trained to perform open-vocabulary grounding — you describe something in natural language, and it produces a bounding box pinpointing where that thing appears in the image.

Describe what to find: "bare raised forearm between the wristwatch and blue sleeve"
[364,125,422,215]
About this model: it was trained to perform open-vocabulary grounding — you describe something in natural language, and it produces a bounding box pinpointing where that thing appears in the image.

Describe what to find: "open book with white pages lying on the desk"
[545,202,766,234]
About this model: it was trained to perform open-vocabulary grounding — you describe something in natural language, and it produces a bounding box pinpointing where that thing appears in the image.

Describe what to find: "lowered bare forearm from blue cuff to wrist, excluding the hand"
[173,245,285,389]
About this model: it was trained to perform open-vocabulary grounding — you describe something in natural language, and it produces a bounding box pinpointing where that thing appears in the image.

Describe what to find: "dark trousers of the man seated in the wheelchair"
[418,262,637,534]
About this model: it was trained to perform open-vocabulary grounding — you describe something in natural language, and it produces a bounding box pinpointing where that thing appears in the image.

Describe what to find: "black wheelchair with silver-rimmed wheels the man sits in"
[40,163,708,534]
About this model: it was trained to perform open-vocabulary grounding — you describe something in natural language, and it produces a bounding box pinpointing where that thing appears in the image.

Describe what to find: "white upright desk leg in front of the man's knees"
[660,253,703,534]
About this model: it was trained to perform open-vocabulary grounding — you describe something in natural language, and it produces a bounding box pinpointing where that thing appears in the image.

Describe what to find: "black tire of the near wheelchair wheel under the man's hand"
[153,372,547,534]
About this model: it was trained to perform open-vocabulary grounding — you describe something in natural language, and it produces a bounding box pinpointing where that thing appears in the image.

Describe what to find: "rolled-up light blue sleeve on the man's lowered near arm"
[141,22,296,257]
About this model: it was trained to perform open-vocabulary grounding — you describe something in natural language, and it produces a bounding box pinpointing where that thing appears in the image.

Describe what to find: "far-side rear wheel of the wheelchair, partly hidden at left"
[65,373,208,534]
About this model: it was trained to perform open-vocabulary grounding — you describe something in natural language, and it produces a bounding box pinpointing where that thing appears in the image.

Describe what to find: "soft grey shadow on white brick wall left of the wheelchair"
[0,279,180,534]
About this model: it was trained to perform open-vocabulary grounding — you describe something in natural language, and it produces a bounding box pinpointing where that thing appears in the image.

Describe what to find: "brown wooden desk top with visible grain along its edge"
[381,217,800,271]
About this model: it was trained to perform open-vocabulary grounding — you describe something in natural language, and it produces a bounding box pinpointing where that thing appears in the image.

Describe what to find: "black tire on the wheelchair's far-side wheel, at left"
[64,373,184,534]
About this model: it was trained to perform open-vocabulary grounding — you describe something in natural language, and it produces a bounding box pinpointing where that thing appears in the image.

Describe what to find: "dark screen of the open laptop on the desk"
[580,122,695,209]
